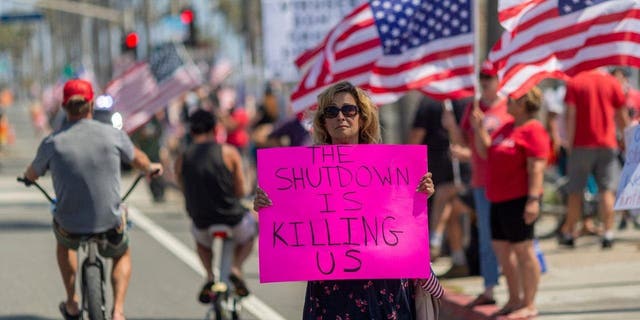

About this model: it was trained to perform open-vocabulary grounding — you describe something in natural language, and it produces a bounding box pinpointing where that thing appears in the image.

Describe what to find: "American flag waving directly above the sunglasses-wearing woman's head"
[291,0,474,112]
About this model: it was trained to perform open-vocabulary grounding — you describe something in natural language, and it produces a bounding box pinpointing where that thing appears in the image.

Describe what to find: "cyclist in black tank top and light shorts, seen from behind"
[175,110,257,303]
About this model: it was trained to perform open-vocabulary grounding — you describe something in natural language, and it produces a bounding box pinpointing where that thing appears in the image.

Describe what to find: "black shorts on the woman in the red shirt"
[491,196,534,243]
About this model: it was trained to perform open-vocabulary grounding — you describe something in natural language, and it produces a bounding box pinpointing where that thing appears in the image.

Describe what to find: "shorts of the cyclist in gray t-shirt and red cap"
[53,219,129,258]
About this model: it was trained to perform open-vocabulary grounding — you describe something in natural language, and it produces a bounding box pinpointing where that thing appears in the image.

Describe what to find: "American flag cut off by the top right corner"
[489,0,640,96]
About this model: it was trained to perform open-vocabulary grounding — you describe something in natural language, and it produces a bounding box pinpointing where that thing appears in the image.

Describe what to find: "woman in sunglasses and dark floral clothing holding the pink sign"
[254,82,443,320]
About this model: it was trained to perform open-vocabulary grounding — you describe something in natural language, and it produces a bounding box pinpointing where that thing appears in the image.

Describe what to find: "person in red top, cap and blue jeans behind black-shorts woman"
[442,61,511,308]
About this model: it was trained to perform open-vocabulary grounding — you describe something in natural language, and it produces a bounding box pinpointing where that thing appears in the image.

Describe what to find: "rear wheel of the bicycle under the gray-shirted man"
[82,249,106,320]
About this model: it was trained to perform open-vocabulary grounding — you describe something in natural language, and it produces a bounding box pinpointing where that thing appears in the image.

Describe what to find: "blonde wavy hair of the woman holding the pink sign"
[313,81,382,144]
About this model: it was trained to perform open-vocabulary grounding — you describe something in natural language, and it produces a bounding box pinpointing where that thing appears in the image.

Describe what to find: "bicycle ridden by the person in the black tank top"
[205,224,243,320]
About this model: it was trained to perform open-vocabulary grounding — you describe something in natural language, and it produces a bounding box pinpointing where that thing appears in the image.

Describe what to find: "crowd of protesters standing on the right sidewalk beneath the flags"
[408,64,640,318]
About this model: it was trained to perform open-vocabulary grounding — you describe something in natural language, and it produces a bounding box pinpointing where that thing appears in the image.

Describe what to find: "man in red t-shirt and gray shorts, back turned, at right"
[559,69,629,249]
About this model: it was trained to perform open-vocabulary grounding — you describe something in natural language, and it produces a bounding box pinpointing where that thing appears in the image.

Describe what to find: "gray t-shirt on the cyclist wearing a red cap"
[31,119,134,234]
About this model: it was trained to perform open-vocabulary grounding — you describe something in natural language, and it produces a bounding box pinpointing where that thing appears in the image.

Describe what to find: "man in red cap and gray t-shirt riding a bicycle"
[24,79,162,320]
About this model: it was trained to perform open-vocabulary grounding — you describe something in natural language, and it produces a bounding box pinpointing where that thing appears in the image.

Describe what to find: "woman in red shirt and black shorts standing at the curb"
[471,88,550,319]
